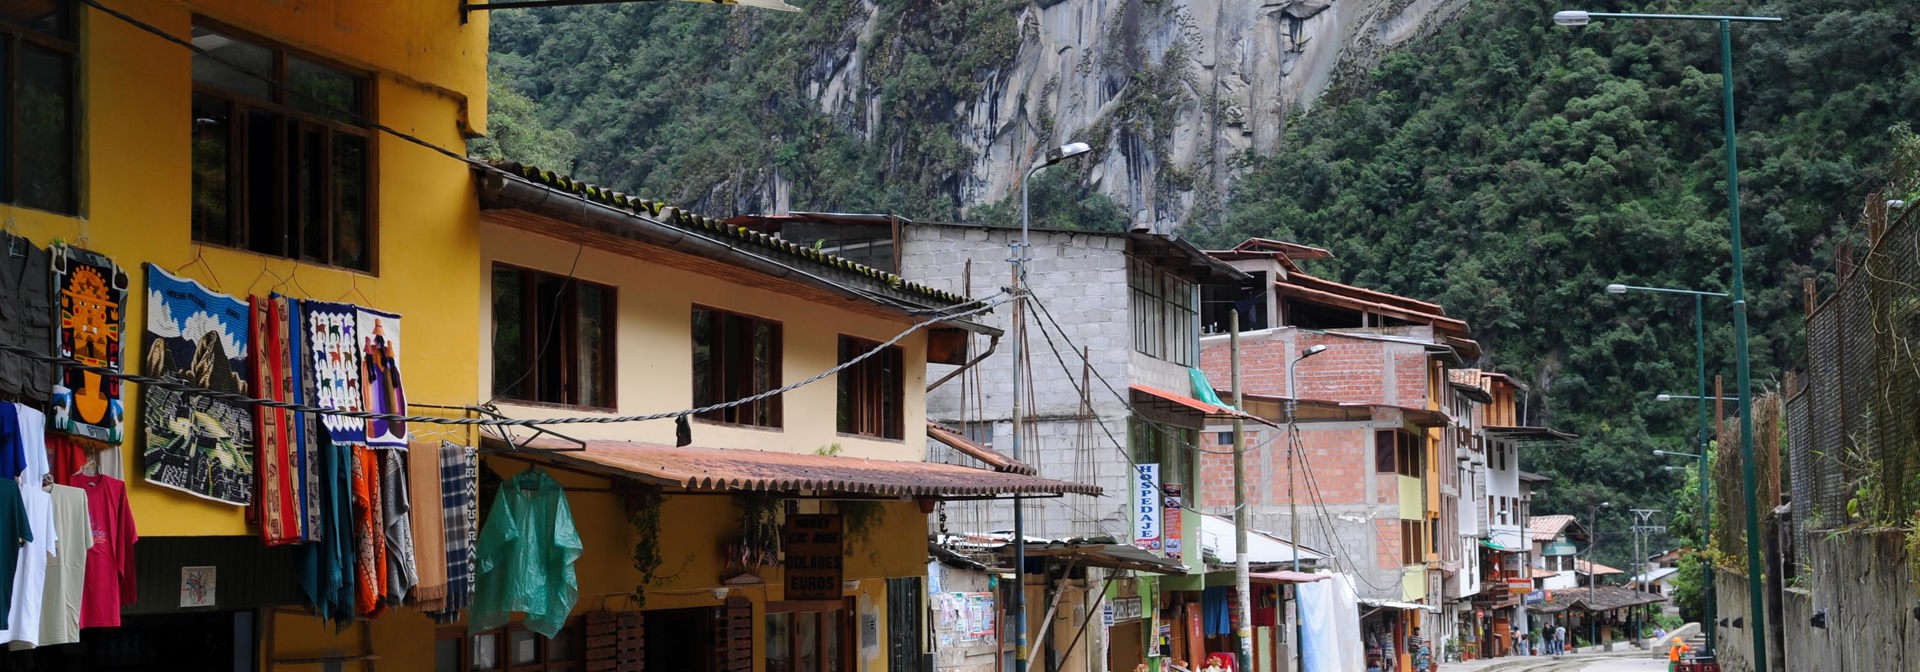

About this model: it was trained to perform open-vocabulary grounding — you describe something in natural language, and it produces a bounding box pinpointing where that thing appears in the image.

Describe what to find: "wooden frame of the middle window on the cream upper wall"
[687,303,787,430]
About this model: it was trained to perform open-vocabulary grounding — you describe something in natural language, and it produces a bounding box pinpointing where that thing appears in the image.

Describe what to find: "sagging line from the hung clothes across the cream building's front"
[0,292,1010,426]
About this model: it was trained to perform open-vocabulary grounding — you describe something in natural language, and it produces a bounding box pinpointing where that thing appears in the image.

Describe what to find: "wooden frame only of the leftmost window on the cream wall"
[488,261,620,411]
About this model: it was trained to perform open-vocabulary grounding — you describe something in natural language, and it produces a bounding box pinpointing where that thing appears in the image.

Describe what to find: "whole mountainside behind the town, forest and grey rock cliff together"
[492,0,1920,561]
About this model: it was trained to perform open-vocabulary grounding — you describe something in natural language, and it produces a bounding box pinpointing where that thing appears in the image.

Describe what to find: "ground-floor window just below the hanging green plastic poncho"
[434,618,586,672]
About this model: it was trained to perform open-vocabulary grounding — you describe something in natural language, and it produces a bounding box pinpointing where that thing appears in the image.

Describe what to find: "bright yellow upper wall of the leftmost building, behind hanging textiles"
[0,0,488,536]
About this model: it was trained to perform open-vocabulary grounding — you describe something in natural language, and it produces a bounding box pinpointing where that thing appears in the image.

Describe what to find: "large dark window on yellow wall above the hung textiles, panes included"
[192,21,374,271]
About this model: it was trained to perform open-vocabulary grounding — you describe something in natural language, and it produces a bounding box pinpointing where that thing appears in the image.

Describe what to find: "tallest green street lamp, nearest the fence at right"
[1553,10,1780,660]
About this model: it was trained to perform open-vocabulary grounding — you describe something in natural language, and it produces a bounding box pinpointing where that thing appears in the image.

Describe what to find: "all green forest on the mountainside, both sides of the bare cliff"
[493,0,1920,599]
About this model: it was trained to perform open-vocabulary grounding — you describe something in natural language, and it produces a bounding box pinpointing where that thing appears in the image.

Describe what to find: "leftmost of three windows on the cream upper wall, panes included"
[493,263,618,409]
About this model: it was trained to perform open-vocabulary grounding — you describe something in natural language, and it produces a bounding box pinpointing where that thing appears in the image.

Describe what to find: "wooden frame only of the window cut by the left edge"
[0,0,86,217]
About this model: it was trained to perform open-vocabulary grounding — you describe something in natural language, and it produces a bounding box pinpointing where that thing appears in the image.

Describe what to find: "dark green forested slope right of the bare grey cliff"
[1200,0,1920,576]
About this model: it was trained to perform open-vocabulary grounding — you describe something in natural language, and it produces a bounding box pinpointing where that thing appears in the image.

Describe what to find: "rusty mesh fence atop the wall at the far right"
[1786,208,1920,563]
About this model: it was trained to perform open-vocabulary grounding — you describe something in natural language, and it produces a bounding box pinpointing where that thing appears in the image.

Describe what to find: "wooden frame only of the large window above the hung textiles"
[192,15,380,276]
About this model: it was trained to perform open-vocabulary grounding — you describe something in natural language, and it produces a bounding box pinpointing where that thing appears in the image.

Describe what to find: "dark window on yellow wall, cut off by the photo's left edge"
[0,2,79,215]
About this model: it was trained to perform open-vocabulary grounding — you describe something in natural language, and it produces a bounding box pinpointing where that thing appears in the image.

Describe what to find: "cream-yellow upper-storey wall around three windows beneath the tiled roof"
[468,223,927,458]
